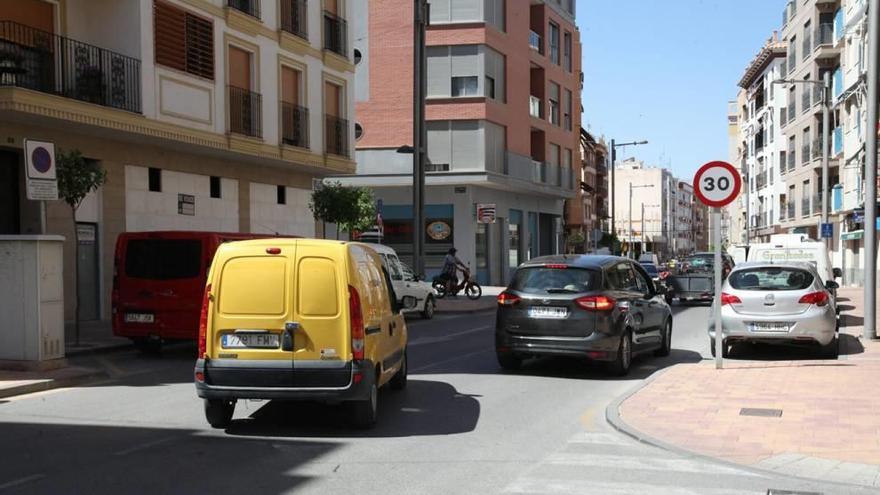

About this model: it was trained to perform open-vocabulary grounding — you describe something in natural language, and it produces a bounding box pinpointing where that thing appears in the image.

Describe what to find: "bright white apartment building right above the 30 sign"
[738,33,788,242]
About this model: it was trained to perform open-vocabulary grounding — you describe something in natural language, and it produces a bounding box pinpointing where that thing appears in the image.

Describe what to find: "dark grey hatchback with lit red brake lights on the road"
[495,255,672,375]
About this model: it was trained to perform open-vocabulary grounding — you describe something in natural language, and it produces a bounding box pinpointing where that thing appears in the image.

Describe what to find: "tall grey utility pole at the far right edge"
[864,0,880,339]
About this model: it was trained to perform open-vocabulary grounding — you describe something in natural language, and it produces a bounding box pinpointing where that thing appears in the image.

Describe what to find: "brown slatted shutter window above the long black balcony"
[153,1,214,80]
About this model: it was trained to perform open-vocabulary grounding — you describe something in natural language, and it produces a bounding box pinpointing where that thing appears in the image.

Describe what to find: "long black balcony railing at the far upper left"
[0,21,141,113]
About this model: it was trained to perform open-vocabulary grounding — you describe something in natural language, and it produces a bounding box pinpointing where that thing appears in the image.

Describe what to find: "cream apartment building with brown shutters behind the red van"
[0,0,360,320]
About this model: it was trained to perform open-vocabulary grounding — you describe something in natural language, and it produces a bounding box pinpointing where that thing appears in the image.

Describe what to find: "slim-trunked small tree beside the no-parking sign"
[55,150,107,345]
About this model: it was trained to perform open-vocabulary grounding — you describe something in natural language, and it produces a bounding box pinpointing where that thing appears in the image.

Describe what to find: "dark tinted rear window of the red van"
[125,239,202,280]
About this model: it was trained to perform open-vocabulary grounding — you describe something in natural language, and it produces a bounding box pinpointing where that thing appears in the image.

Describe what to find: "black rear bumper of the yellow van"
[195,359,376,401]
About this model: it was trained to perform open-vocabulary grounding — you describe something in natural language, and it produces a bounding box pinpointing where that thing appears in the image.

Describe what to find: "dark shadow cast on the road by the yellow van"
[226,379,480,438]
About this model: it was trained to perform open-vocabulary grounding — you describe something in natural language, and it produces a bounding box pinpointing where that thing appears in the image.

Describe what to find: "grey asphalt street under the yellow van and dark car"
[0,307,870,495]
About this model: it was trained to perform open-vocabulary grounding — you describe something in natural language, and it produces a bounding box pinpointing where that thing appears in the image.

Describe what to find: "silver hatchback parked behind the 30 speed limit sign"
[709,262,837,359]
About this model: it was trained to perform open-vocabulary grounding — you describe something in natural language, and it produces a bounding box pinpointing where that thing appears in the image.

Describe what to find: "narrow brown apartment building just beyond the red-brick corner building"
[565,129,608,253]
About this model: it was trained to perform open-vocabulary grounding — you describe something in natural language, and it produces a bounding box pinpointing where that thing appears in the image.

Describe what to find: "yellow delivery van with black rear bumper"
[195,238,415,428]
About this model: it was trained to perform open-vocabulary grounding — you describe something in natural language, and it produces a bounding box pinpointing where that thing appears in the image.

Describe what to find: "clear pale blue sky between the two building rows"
[577,0,786,181]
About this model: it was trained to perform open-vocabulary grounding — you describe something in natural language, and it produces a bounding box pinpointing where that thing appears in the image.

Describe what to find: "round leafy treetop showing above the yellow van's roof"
[309,182,376,239]
